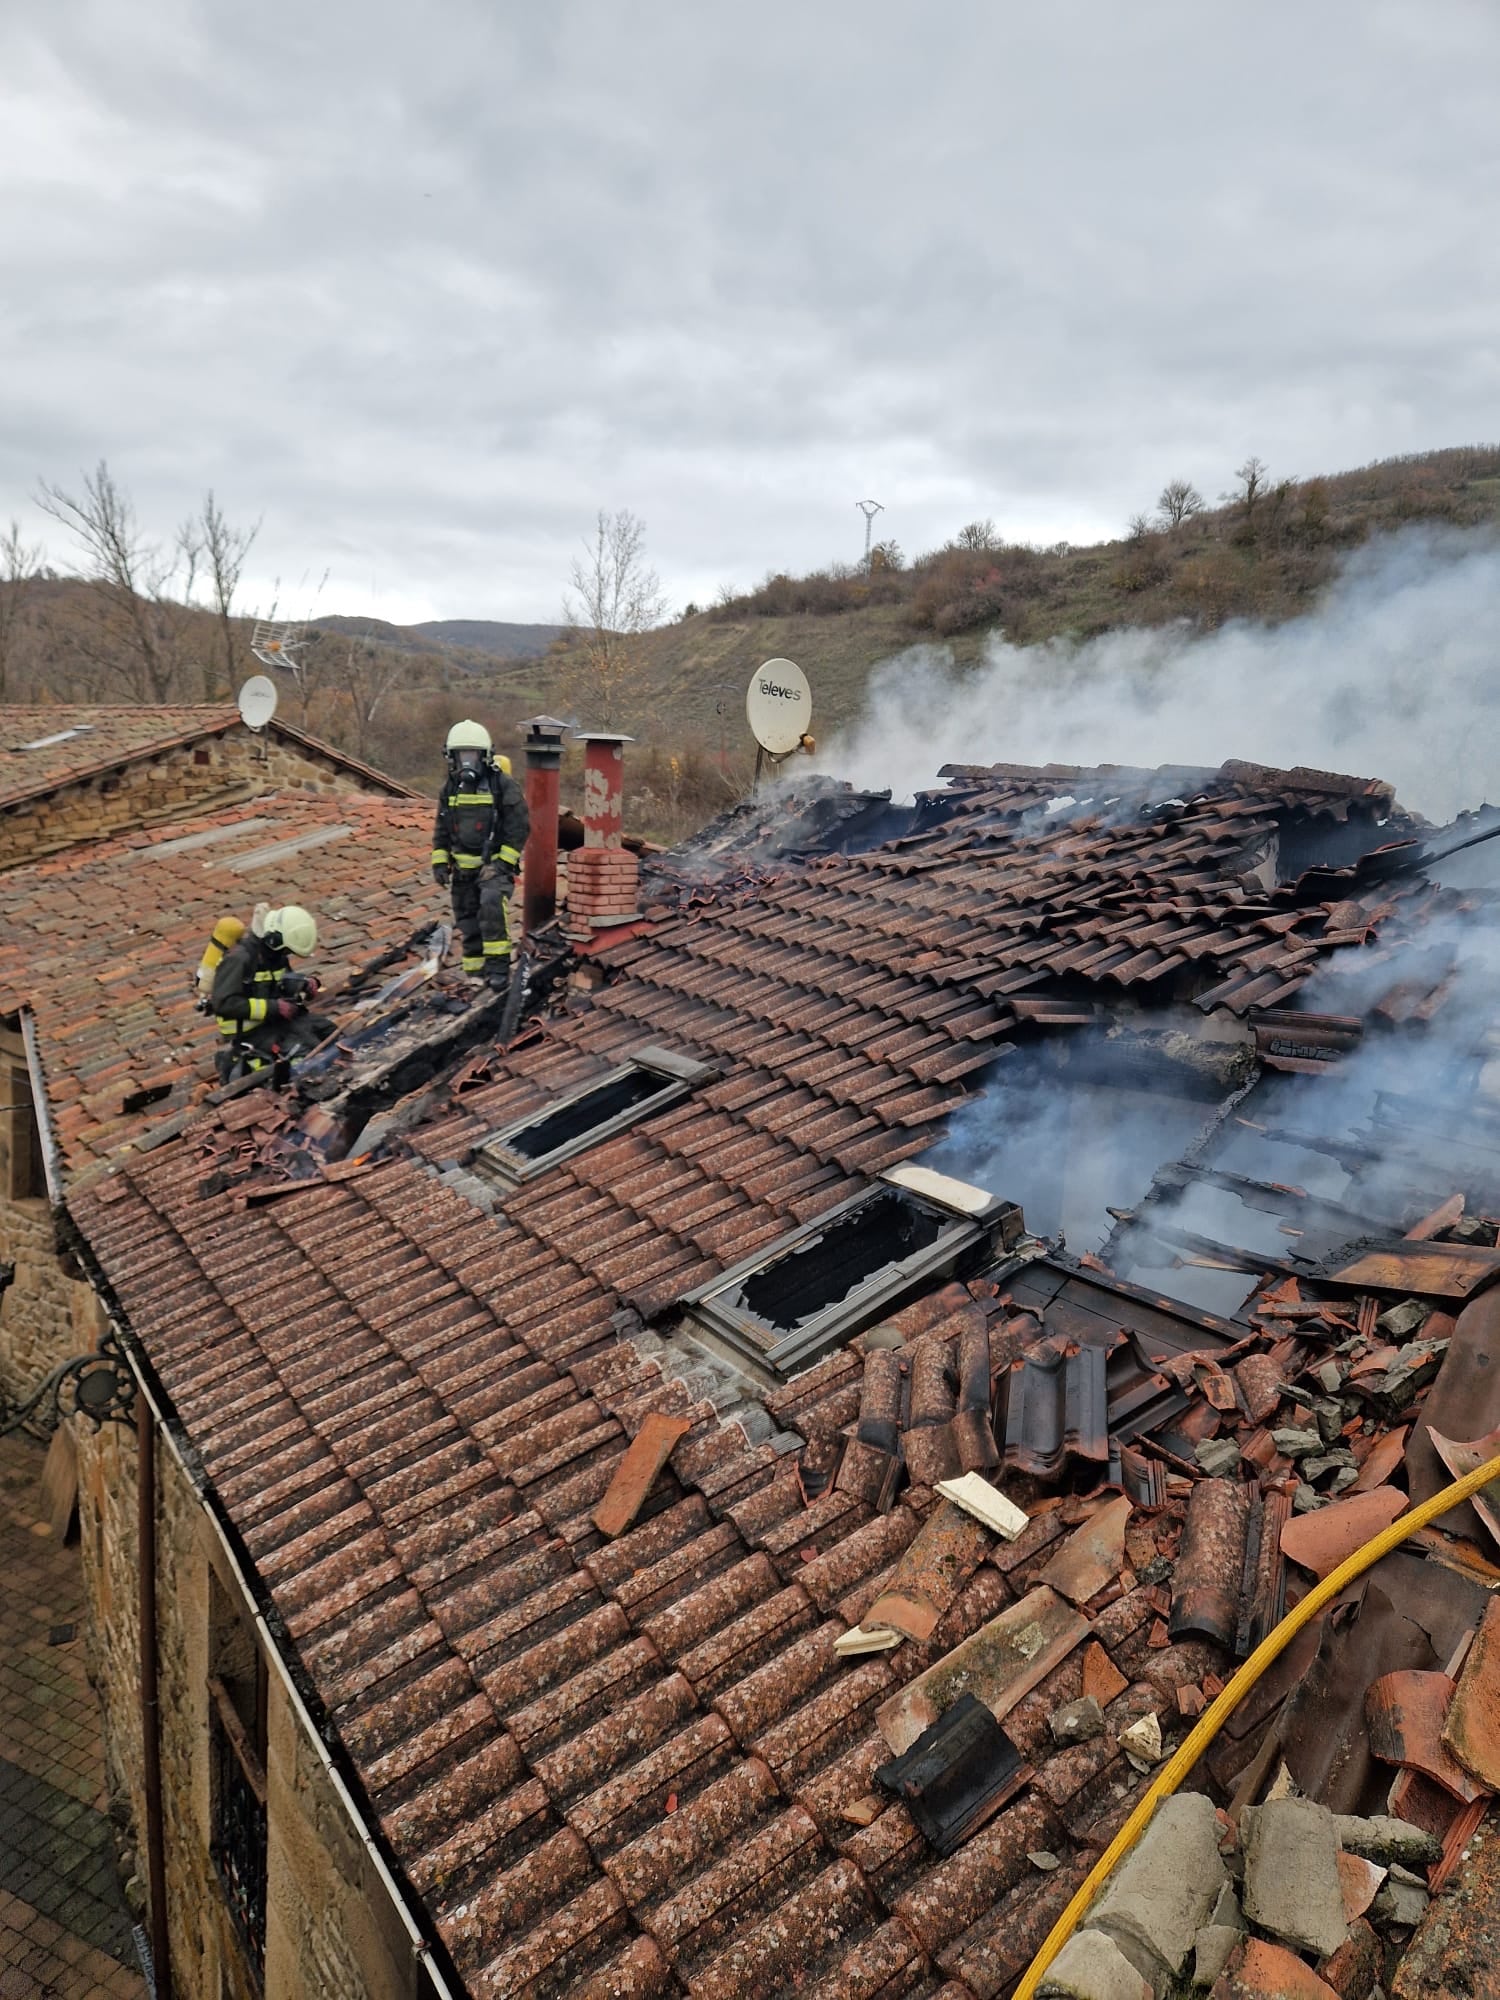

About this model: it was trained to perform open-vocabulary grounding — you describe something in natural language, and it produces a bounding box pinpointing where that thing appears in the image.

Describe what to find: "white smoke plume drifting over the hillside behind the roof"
[814,528,1500,822]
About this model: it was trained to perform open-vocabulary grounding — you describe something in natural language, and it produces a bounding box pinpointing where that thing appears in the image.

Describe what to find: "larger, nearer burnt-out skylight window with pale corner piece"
[682,1166,1024,1378]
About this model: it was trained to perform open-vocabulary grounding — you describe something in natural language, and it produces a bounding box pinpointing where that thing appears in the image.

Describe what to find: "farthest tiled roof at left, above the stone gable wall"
[0,702,412,810]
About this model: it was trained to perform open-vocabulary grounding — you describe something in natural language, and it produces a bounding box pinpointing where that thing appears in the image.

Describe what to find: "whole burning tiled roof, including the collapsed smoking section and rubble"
[58,766,1500,2000]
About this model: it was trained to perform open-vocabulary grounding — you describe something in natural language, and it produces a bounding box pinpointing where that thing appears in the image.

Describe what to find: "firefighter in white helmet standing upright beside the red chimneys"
[432,722,532,986]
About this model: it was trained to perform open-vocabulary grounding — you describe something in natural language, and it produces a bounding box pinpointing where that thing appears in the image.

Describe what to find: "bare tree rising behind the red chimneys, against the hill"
[562,508,666,728]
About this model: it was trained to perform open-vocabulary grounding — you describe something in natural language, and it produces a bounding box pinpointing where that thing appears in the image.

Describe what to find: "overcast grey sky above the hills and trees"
[0,0,1500,620]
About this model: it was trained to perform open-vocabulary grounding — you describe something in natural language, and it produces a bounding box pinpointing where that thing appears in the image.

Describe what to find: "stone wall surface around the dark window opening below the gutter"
[72,1418,418,2000]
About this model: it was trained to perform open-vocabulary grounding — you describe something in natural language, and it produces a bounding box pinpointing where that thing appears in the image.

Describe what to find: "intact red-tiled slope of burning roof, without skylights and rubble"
[66,768,1500,2000]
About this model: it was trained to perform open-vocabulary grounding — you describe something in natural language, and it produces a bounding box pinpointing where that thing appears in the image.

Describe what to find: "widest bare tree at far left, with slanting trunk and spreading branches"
[36,458,202,702]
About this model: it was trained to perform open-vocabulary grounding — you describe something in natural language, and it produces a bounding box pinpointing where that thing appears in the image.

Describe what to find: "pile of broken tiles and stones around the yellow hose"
[776,1204,1500,2000]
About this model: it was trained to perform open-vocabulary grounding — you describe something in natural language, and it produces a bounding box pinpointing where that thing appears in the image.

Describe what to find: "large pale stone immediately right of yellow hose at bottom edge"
[1086,1792,1230,1996]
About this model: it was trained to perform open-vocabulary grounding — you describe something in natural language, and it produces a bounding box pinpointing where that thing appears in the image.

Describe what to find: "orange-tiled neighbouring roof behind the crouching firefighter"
[0,792,444,1172]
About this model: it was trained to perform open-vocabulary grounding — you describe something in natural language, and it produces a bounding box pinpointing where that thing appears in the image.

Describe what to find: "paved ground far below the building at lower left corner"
[0,1438,146,2000]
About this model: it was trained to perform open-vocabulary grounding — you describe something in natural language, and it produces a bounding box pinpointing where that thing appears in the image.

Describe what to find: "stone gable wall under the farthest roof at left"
[0,722,394,868]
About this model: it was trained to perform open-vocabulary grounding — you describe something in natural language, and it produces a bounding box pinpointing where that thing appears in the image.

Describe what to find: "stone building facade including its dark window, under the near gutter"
[72,1418,432,2000]
